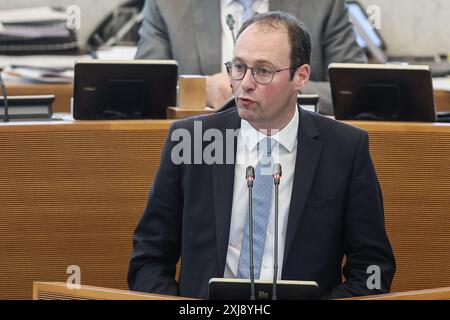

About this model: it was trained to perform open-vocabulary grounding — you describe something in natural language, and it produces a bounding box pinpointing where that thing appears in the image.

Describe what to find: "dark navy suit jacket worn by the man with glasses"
[128,108,395,298]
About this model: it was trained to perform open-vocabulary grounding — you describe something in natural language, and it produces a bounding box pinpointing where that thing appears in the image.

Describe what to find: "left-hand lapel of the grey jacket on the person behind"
[192,0,222,74]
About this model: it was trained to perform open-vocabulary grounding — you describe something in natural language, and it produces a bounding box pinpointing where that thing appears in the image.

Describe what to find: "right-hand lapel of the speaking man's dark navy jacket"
[283,108,322,265]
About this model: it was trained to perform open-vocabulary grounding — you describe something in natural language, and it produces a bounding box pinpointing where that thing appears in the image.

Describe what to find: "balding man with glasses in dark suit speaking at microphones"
[128,12,395,298]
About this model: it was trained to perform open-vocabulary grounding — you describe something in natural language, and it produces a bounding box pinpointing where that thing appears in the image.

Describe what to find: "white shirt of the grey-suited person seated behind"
[220,0,269,72]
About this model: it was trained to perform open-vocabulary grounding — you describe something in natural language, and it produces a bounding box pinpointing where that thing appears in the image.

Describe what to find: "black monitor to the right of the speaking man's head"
[329,63,436,122]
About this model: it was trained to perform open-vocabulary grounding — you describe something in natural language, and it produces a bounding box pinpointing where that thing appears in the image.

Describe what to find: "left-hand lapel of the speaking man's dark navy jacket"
[213,111,241,276]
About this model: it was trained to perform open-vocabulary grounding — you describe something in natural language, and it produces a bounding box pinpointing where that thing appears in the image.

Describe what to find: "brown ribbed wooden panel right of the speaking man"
[356,123,450,292]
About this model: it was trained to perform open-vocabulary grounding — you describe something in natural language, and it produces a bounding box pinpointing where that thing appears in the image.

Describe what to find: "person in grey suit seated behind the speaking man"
[136,0,367,115]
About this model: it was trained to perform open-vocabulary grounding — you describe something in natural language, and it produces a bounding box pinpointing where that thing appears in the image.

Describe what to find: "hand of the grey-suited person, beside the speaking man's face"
[206,73,233,110]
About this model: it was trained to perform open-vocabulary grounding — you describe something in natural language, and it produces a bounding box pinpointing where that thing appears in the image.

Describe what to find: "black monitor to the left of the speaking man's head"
[73,60,178,120]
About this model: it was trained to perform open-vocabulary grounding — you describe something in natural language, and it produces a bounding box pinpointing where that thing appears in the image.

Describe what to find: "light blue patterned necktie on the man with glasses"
[237,138,273,279]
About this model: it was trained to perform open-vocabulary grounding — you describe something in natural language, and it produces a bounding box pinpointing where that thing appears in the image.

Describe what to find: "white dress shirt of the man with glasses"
[224,108,299,280]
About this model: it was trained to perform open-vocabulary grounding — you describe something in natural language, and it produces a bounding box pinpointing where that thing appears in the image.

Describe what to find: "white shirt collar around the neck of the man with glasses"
[241,106,300,152]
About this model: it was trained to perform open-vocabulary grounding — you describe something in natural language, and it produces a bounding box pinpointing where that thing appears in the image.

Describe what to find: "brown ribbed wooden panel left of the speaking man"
[0,120,171,299]
